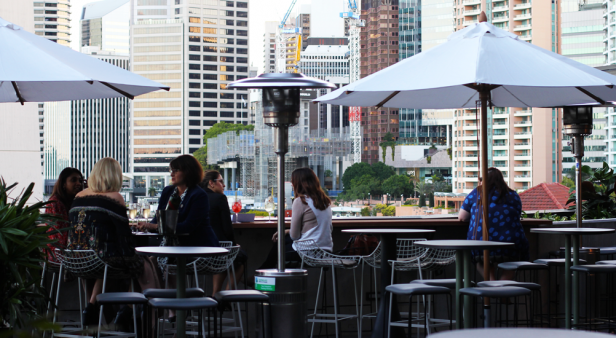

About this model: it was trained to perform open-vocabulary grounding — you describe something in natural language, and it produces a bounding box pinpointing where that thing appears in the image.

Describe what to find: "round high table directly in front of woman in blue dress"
[415,240,514,329]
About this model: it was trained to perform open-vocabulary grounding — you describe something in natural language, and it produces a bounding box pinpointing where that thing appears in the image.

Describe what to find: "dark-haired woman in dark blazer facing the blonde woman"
[138,155,219,246]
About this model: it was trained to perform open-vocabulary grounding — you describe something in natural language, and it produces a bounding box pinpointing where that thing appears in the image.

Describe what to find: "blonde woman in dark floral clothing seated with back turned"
[67,157,161,325]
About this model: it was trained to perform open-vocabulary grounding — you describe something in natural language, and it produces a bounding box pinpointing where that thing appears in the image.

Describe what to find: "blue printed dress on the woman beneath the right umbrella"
[462,189,530,263]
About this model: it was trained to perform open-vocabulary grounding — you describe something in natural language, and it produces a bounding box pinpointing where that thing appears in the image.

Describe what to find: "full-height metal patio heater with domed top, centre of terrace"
[227,73,336,337]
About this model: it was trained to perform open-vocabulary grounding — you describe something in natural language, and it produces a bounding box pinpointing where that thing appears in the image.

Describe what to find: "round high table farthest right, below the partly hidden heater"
[530,228,616,329]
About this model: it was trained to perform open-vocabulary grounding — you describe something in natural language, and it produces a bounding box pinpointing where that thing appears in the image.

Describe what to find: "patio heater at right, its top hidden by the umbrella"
[563,106,592,228]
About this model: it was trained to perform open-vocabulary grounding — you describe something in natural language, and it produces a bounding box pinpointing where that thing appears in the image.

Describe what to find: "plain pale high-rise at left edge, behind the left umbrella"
[0,0,44,203]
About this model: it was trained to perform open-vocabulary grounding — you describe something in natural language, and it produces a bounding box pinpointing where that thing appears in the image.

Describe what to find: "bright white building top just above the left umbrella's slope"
[79,0,130,55]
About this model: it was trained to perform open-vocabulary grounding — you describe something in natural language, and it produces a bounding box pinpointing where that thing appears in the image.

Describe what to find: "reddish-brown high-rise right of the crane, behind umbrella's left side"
[358,0,399,163]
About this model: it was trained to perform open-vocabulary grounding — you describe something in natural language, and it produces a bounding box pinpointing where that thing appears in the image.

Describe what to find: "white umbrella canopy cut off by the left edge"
[0,18,169,104]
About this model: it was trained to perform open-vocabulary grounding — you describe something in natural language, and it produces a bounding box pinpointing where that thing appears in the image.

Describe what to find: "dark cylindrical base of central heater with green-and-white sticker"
[255,269,308,338]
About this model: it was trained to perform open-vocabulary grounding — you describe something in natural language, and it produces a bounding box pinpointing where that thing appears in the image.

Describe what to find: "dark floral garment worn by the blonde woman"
[67,195,143,277]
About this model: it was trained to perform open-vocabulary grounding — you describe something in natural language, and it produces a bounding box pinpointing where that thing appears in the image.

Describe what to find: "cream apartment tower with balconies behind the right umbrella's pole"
[450,0,562,192]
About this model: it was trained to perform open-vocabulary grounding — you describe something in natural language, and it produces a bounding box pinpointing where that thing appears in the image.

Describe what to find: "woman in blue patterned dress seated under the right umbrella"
[458,168,530,280]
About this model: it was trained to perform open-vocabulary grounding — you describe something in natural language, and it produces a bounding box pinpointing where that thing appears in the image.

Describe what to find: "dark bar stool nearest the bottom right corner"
[571,261,616,333]
